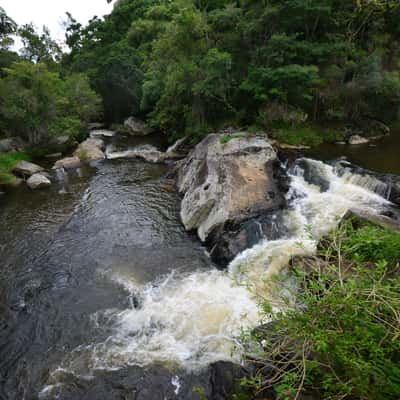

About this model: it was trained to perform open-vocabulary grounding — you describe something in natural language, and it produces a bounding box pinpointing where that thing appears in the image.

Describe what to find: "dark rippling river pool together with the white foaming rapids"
[0,137,396,400]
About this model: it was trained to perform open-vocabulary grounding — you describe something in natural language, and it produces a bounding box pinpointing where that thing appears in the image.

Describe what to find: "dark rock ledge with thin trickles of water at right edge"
[331,159,400,205]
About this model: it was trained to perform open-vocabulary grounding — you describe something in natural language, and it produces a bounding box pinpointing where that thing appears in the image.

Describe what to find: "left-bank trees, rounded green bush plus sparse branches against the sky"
[0,9,101,145]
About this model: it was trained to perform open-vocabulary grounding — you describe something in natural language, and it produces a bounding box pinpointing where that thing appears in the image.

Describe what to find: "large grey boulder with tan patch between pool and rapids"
[178,134,287,261]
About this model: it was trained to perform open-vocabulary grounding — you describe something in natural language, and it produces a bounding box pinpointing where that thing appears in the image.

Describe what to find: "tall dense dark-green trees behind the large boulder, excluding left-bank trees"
[59,0,400,141]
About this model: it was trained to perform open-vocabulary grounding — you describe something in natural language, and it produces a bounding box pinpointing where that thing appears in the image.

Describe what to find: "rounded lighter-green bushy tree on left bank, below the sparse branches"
[0,61,99,144]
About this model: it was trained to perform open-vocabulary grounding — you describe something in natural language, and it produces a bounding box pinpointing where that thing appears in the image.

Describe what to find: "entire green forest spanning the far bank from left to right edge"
[0,0,400,141]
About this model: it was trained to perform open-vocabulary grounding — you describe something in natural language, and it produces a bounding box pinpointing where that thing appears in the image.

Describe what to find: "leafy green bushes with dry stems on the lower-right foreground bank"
[237,222,400,400]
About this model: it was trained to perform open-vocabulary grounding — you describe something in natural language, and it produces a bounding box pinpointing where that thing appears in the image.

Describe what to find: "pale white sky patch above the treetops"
[0,0,113,45]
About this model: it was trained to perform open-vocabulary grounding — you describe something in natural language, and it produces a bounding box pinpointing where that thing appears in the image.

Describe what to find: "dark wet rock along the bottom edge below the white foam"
[40,361,246,400]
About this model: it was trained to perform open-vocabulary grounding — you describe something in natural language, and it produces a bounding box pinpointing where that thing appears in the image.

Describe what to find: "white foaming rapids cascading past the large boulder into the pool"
[41,160,389,394]
